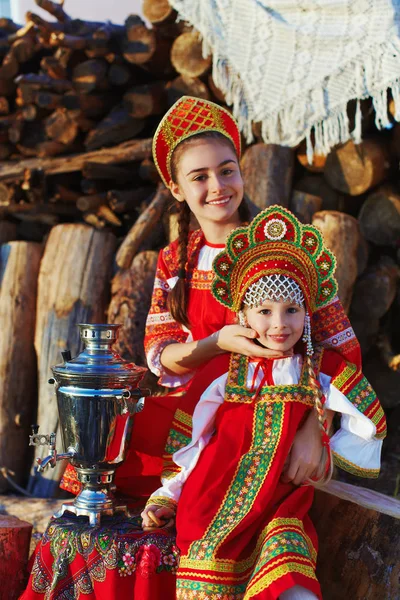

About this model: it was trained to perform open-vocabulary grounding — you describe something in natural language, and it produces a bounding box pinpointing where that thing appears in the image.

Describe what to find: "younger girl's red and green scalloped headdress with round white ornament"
[212,206,337,314]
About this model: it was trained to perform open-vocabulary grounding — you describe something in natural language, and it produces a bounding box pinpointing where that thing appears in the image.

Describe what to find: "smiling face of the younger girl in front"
[244,300,306,352]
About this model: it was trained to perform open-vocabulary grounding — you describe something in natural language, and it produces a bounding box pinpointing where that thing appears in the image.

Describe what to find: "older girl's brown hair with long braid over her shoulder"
[168,131,250,327]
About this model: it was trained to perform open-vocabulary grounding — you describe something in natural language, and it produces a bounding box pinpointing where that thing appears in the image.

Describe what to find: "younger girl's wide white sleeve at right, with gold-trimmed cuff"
[319,373,382,477]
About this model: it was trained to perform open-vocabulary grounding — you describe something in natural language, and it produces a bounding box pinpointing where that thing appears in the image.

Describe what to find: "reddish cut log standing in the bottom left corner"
[0,515,32,600]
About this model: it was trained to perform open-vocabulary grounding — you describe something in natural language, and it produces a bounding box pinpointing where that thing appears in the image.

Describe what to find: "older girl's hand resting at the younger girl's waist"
[281,410,323,485]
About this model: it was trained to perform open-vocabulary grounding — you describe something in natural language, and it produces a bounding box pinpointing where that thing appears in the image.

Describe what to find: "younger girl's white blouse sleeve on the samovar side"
[148,373,228,504]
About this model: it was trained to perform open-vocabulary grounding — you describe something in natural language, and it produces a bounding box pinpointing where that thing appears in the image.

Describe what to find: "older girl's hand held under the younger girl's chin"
[214,325,293,358]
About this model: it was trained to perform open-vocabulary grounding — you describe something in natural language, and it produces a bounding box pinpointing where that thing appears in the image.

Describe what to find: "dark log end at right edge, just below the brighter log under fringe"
[358,186,400,247]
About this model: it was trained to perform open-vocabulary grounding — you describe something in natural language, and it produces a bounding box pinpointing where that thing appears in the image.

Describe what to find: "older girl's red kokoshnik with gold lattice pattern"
[153,96,241,187]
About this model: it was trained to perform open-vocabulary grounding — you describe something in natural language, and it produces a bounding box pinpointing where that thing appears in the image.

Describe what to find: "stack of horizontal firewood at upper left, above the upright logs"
[0,0,221,241]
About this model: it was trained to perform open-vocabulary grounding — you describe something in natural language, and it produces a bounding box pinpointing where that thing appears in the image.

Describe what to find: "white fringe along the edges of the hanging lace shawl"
[169,0,400,163]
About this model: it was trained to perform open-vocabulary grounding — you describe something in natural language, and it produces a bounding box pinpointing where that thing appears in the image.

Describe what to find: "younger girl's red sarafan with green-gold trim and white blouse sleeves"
[149,349,386,600]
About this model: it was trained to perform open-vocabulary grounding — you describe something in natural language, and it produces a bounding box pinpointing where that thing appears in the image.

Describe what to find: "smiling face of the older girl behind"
[171,137,243,229]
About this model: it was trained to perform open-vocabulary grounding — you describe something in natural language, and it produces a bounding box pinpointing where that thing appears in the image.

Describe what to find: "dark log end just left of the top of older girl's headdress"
[123,81,167,119]
